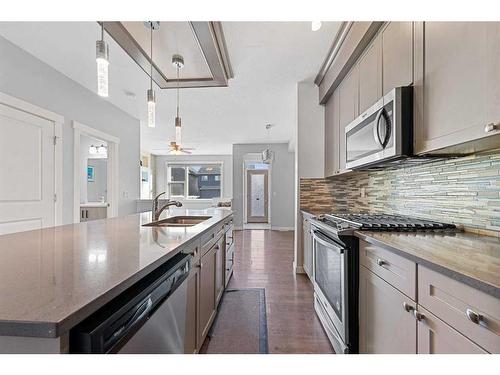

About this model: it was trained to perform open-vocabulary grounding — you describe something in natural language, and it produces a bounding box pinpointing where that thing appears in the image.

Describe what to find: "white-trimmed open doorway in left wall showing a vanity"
[73,122,120,223]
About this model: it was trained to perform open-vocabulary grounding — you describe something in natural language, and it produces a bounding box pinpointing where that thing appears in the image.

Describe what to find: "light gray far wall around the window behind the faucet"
[154,155,233,208]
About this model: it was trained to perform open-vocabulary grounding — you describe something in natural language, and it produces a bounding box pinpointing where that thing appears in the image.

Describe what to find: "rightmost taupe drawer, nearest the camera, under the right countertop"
[418,266,500,353]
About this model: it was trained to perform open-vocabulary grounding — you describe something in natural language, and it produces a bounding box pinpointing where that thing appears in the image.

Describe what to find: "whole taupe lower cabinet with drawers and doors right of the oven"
[359,241,500,354]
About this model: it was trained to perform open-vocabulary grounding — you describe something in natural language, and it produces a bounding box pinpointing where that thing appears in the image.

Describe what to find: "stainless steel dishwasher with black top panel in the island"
[70,254,191,354]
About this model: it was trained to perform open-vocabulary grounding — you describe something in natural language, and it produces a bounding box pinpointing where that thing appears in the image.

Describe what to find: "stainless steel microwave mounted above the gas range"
[345,87,413,169]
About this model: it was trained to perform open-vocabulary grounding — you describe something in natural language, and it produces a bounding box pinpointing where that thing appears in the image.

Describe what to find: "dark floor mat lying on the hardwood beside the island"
[200,288,269,354]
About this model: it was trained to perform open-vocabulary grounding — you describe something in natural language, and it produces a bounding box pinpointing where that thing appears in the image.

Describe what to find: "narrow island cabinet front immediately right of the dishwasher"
[184,261,200,354]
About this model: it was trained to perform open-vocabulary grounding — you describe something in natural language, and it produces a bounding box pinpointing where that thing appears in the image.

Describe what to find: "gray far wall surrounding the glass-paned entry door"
[233,143,295,228]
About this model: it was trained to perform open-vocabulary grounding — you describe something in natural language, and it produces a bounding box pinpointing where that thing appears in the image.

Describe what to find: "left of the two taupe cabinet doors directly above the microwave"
[358,35,382,113]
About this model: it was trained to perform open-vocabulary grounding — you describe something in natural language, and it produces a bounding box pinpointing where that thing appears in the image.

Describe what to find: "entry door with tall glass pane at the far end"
[247,169,269,223]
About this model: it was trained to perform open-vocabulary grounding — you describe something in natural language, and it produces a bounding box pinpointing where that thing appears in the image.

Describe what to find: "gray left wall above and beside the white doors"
[0,37,140,224]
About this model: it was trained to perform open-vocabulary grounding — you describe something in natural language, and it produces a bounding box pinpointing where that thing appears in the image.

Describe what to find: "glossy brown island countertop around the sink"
[0,208,233,337]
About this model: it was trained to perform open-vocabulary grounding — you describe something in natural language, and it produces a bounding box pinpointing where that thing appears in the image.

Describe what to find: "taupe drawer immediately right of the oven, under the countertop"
[359,240,417,300]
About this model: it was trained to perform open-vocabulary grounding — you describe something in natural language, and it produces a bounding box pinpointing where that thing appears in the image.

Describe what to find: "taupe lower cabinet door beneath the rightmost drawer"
[418,307,487,354]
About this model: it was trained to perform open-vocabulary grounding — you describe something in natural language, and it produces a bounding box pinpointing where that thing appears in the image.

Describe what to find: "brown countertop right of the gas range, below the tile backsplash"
[355,231,500,298]
